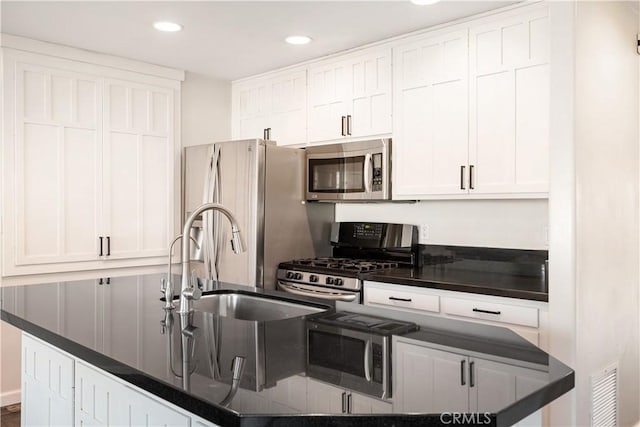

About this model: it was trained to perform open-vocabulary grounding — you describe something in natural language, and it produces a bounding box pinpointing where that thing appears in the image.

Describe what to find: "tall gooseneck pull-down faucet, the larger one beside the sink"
[178,203,244,313]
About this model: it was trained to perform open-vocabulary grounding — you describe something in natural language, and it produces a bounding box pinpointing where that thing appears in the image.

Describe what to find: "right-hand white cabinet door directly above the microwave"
[345,49,392,137]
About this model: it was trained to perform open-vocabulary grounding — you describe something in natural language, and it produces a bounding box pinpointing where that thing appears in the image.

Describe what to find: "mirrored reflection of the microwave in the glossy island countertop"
[307,320,391,398]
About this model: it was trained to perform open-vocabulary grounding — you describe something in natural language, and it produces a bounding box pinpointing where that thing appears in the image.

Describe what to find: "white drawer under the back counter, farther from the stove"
[442,297,538,328]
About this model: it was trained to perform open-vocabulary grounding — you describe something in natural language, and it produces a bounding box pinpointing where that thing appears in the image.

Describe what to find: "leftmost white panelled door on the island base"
[20,333,74,426]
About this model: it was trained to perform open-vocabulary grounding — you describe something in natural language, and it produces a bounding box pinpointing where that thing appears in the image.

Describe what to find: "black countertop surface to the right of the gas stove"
[360,270,549,302]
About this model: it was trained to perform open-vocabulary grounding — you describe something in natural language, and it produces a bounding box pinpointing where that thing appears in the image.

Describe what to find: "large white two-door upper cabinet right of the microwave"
[393,6,550,199]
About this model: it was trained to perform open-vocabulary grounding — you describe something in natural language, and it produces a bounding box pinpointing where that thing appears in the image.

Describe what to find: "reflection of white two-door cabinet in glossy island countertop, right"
[393,338,547,426]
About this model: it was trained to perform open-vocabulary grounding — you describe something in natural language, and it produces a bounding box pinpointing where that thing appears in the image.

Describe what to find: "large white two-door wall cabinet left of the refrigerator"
[2,48,179,276]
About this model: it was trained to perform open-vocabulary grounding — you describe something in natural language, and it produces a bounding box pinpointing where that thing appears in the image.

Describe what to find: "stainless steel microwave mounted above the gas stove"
[306,139,391,201]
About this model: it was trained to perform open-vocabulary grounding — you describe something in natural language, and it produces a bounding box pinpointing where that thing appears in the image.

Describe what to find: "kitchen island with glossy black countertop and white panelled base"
[1,275,574,426]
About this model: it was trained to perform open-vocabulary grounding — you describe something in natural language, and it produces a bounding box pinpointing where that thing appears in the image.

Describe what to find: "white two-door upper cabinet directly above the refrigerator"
[232,69,307,145]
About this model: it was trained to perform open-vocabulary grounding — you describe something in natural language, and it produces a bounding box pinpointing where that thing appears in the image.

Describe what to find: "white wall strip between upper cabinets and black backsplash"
[336,200,548,249]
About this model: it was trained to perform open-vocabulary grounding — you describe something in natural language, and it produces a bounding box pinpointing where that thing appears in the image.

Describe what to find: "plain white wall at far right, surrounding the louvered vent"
[575,2,640,426]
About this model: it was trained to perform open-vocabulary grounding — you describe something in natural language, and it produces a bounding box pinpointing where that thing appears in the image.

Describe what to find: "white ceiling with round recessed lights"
[0,0,515,80]
